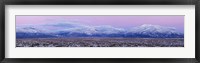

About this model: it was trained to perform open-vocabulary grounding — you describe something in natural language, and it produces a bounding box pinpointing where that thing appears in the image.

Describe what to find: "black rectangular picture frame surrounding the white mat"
[0,0,200,63]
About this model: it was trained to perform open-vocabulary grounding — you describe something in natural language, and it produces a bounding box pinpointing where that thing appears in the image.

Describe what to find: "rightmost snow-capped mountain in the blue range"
[128,24,183,38]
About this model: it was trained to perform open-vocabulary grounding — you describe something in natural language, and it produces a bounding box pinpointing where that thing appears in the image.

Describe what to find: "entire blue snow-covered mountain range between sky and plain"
[16,22,184,38]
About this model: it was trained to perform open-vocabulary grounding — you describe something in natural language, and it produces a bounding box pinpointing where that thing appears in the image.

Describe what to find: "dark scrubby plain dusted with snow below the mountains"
[16,38,184,47]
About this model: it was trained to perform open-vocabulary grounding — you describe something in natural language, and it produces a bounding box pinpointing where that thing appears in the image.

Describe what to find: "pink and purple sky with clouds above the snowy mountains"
[16,16,184,32]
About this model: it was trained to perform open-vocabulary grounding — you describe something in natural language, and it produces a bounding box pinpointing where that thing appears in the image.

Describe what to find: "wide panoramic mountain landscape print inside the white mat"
[16,15,184,47]
